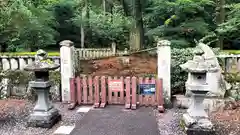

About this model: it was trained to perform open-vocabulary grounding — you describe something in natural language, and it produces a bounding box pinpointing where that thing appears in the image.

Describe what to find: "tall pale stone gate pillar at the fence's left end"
[60,40,75,103]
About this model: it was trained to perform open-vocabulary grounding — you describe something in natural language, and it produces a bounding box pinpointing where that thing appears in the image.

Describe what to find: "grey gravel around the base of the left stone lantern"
[0,100,83,135]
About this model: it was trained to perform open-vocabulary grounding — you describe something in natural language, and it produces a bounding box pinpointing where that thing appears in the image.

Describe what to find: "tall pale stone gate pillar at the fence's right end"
[157,40,171,105]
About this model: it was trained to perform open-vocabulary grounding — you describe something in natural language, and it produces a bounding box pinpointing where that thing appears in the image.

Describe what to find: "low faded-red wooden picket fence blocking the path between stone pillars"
[70,76,164,112]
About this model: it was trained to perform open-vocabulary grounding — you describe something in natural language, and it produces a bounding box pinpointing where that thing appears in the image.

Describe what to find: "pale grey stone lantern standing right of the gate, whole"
[180,47,219,135]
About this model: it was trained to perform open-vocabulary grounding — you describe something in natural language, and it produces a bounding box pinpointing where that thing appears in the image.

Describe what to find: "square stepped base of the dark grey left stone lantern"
[27,108,61,128]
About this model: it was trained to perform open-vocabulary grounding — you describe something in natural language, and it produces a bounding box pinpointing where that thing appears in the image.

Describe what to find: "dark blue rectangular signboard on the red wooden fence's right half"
[139,84,156,95]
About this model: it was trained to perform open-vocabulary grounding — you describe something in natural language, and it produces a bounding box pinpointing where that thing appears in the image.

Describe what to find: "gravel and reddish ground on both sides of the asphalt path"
[3,99,240,135]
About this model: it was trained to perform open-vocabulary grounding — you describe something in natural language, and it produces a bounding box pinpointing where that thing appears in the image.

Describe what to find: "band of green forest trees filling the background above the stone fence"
[0,0,237,51]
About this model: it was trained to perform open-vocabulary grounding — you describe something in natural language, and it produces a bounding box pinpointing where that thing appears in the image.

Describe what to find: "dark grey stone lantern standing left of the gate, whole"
[24,50,61,128]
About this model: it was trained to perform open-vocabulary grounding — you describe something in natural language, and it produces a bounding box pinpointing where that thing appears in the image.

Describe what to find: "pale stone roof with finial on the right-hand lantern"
[180,47,219,73]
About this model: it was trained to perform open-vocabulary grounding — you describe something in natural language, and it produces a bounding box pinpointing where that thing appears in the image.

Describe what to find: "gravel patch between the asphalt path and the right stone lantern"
[155,108,186,135]
